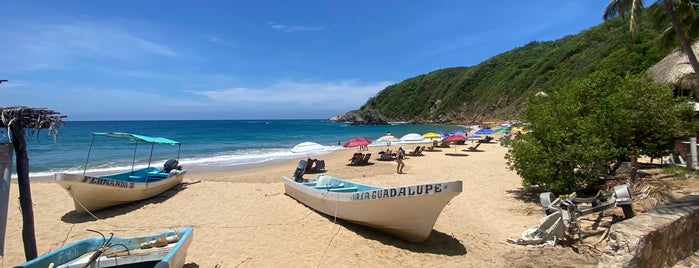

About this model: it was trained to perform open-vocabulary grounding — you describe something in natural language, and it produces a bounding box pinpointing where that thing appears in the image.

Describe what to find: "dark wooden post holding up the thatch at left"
[10,124,38,261]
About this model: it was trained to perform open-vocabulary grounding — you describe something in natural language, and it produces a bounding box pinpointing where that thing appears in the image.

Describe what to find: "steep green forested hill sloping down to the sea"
[344,11,672,123]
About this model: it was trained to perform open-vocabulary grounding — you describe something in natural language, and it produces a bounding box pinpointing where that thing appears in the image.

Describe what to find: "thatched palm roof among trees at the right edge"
[648,41,699,90]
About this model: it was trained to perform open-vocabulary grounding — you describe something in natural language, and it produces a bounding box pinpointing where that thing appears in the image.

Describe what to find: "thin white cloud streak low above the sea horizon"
[190,80,394,110]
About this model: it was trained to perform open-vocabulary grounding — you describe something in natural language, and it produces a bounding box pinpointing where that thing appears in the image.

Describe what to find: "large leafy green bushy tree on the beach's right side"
[506,72,696,192]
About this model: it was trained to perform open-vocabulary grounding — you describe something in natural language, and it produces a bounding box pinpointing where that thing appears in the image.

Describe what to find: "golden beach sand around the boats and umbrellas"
[2,143,608,267]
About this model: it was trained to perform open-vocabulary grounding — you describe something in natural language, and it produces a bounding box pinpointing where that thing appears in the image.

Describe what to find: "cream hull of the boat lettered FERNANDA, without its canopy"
[55,170,186,213]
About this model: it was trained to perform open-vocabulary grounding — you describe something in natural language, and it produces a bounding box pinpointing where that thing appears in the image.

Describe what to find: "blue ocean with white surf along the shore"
[0,120,467,178]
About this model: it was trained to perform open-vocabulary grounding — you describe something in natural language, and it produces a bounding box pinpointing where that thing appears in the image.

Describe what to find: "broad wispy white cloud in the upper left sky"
[0,21,179,69]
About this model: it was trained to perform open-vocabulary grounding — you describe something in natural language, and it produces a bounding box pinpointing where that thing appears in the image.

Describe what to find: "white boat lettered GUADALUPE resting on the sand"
[282,174,463,242]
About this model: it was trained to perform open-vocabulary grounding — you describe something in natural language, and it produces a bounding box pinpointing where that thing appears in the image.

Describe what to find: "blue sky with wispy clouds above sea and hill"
[0,0,608,120]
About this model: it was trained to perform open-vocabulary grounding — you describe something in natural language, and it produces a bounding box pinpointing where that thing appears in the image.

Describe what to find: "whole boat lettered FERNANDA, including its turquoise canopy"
[55,132,187,213]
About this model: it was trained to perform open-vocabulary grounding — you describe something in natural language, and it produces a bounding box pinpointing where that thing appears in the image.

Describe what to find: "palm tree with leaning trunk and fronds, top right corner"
[602,0,699,86]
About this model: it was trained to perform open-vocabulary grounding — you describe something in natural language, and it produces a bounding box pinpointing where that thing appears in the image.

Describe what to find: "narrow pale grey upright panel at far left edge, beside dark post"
[0,143,13,256]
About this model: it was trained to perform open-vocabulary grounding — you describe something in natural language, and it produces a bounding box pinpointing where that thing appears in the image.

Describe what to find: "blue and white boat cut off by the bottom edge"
[15,227,194,268]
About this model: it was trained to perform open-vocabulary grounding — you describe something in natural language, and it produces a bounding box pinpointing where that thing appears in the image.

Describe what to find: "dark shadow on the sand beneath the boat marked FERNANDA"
[61,181,200,223]
